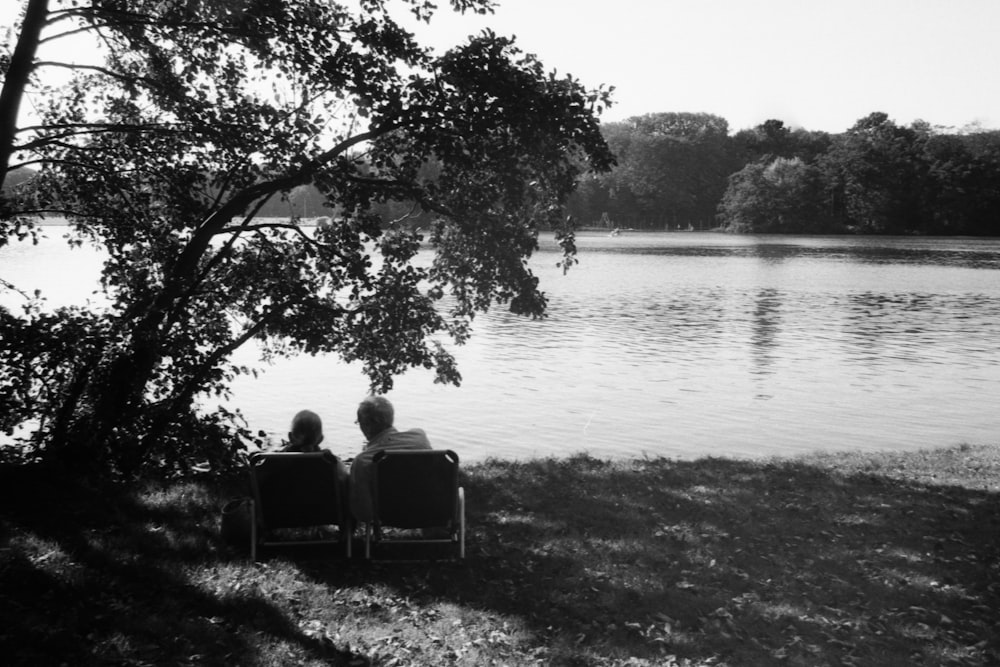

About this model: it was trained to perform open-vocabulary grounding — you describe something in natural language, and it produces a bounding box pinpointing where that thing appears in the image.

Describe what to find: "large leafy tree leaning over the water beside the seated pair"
[0,0,613,477]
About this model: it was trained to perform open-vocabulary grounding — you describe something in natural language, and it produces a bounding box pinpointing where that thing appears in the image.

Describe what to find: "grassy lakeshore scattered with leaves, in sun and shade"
[0,446,1000,667]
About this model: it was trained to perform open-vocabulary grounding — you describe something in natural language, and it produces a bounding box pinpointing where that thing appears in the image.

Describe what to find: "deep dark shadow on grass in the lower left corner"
[0,469,364,666]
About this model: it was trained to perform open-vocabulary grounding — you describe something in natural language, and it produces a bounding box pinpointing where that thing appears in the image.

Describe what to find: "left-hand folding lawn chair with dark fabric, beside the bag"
[250,450,352,560]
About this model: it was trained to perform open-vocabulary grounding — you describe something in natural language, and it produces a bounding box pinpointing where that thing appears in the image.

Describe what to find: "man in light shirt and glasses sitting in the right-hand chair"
[351,396,431,522]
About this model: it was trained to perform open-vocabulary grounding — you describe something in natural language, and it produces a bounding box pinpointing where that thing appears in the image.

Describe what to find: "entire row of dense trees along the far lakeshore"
[568,112,1000,235]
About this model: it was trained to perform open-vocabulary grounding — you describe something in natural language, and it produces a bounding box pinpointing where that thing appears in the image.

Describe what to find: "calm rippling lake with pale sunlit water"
[0,228,1000,460]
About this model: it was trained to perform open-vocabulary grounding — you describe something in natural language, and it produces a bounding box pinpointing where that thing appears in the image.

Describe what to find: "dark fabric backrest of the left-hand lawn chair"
[250,450,345,528]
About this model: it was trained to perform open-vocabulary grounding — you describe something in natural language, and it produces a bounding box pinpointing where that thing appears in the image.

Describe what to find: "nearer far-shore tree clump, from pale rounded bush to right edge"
[719,112,1000,235]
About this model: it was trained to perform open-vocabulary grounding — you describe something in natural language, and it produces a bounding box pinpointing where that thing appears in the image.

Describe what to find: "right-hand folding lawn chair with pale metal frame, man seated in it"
[365,449,465,558]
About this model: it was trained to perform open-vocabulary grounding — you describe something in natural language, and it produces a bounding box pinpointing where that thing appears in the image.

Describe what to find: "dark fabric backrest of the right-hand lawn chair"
[372,449,458,528]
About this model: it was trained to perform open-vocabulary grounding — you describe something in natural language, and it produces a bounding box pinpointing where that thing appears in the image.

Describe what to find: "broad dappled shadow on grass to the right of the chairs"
[296,457,1000,665]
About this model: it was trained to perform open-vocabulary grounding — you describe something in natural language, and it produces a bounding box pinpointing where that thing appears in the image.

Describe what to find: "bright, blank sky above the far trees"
[0,0,1000,132]
